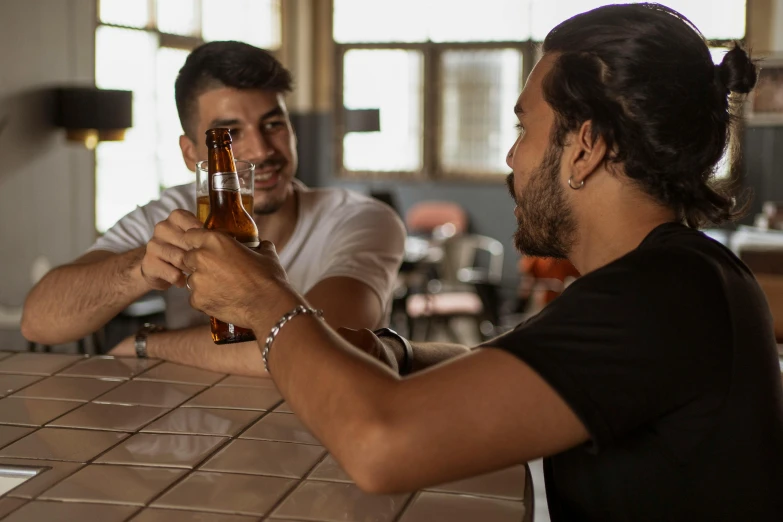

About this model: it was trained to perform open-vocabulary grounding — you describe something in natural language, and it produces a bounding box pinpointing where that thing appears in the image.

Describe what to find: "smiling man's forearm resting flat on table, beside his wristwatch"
[146,326,269,377]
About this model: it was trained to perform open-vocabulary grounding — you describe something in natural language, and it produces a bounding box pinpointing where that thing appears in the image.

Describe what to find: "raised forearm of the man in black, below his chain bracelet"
[260,294,400,481]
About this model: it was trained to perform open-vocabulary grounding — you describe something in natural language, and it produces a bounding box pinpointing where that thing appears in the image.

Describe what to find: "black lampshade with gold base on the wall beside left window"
[54,87,133,139]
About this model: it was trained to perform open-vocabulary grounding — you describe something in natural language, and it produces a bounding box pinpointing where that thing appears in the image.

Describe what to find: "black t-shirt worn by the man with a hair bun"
[486,223,783,522]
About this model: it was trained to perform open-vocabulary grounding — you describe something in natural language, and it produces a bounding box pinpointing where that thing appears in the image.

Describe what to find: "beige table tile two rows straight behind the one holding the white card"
[48,402,169,432]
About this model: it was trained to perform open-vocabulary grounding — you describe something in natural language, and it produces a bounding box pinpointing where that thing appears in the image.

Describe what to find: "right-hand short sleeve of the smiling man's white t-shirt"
[319,201,405,308]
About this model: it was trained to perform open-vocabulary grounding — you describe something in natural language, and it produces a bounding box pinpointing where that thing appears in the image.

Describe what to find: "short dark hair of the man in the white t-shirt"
[174,41,293,139]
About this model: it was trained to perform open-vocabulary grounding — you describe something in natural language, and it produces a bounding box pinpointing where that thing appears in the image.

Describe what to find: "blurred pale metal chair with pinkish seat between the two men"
[405,234,503,342]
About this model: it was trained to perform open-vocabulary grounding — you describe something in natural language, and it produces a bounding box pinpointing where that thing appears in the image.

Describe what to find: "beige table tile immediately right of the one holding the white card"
[39,464,185,506]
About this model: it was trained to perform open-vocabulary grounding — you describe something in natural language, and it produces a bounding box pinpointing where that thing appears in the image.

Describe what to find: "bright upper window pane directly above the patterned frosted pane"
[428,0,530,42]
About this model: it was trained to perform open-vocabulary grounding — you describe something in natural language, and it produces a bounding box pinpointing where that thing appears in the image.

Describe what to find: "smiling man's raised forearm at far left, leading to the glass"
[22,248,150,344]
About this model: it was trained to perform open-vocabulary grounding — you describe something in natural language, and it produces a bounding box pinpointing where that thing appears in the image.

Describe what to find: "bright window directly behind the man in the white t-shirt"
[95,0,281,232]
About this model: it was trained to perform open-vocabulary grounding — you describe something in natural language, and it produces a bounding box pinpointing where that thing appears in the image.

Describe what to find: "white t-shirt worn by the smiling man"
[89,180,405,329]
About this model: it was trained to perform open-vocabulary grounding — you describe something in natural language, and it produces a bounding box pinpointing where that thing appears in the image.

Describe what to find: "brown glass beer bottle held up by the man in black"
[204,128,259,344]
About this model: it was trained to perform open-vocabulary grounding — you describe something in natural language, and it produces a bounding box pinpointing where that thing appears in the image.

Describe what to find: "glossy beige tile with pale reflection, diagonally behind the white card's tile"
[96,433,227,468]
